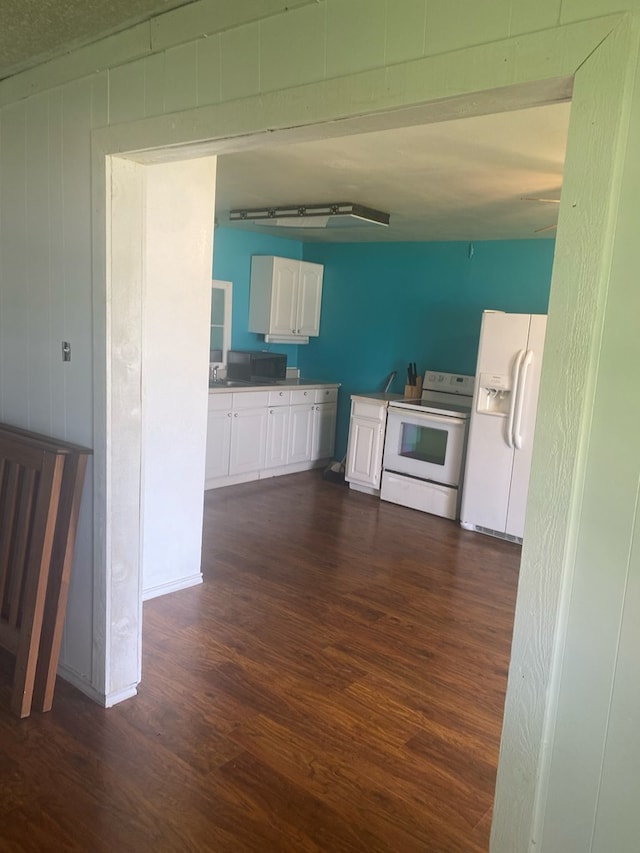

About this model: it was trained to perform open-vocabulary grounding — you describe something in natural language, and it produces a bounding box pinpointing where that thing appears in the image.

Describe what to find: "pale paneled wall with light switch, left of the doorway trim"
[0,73,108,683]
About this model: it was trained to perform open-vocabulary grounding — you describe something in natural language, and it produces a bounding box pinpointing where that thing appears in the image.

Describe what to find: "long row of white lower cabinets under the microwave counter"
[205,386,338,489]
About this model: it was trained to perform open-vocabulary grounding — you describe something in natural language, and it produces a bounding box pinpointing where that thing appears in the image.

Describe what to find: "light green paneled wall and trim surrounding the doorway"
[0,0,640,853]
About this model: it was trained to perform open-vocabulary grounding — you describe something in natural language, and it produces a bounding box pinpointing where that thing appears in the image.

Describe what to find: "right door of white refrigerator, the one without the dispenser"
[505,314,547,539]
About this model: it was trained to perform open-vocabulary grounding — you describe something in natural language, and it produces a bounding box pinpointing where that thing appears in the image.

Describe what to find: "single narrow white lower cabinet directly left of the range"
[345,396,396,494]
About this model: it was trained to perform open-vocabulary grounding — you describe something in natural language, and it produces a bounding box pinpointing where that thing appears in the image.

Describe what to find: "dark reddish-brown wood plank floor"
[0,471,520,853]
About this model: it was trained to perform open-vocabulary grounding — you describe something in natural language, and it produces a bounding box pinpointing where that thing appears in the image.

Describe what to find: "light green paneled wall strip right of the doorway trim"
[536,21,640,853]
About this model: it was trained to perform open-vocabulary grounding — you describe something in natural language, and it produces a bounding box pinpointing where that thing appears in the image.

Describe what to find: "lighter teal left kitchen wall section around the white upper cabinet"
[213,228,302,367]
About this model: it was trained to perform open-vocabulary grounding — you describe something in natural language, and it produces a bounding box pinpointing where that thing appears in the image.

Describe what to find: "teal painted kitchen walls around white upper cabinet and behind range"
[213,228,555,457]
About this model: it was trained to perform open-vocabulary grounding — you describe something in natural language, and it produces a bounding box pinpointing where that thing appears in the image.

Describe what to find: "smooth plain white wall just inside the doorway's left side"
[142,158,215,599]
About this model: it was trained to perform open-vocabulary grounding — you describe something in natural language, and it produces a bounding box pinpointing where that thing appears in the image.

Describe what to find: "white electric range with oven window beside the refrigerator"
[380,371,475,519]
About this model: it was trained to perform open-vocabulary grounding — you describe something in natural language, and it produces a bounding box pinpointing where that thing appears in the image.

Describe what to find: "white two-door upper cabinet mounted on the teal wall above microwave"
[249,255,323,344]
